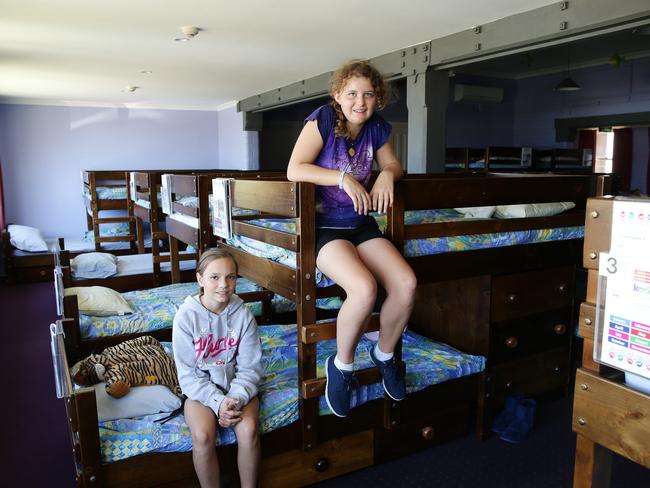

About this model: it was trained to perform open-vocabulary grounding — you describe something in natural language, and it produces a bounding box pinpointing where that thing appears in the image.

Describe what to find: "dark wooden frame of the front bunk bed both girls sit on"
[57,174,606,486]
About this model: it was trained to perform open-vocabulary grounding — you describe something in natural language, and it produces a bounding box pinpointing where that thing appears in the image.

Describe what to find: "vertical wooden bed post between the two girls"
[291,183,319,449]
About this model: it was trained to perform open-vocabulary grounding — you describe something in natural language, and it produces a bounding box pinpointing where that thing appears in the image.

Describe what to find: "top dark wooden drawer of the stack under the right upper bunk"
[490,266,574,322]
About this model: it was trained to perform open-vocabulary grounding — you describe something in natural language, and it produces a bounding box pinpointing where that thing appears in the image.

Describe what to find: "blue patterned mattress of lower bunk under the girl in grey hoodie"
[99,324,485,462]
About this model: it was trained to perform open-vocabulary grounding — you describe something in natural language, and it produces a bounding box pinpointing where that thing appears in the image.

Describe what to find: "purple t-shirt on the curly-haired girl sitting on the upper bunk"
[305,105,392,229]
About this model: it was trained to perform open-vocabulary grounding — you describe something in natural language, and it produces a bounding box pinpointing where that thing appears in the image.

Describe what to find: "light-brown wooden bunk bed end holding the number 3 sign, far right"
[573,198,650,488]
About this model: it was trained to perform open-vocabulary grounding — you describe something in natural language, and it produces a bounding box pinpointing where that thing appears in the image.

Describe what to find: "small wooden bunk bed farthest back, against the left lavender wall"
[81,170,137,254]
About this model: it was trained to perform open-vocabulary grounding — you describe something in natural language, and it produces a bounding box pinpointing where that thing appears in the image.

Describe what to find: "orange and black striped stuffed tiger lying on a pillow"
[74,336,183,398]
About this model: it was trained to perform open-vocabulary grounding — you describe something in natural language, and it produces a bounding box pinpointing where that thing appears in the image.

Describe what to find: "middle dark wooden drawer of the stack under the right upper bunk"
[489,307,572,364]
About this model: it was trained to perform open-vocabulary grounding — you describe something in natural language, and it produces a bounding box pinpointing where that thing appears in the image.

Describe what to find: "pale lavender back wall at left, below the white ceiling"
[0,105,229,238]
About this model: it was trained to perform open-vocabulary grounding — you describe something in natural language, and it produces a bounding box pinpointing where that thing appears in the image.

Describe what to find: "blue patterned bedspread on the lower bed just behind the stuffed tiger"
[79,278,341,339]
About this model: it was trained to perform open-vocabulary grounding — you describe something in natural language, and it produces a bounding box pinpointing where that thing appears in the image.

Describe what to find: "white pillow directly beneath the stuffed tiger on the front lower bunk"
[91,383,181,421]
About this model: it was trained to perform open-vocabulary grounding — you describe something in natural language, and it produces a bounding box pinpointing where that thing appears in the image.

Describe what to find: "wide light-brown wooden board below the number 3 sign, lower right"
[573,368,650,468]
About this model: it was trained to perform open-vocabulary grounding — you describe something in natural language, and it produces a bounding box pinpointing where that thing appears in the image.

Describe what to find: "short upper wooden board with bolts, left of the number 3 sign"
[582,197,614,269]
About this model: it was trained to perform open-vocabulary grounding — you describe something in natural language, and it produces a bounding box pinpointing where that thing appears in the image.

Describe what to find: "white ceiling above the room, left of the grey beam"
[0,0,555,110]
